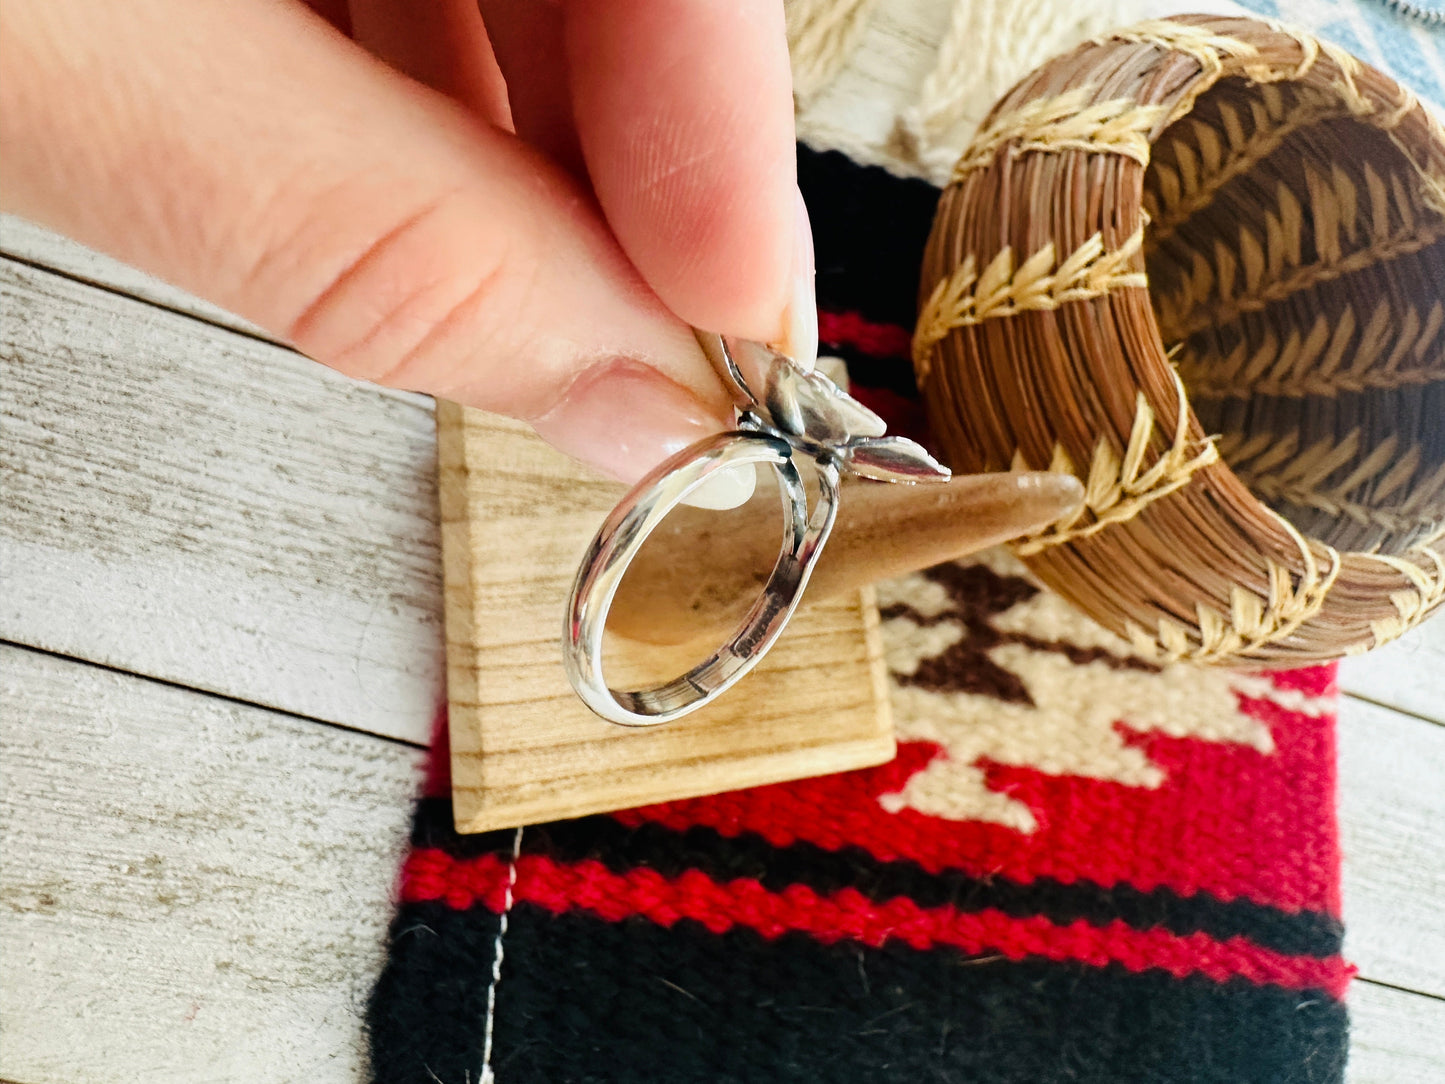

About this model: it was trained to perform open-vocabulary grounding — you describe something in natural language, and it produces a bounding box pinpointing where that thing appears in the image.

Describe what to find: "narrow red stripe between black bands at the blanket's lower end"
[402,848,1351,997]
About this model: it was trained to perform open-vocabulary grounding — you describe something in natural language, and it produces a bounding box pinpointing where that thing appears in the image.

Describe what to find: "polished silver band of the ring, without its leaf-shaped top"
[562,432,838,727]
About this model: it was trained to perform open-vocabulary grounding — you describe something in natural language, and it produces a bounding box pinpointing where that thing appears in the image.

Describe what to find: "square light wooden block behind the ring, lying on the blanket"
[436,402,893,831]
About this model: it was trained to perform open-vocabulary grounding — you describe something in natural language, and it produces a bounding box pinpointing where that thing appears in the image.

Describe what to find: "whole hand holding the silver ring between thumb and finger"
[0,0,816,480]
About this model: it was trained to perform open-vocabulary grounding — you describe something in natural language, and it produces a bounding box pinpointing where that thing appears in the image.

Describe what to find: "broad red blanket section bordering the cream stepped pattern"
[614,687,1340,915]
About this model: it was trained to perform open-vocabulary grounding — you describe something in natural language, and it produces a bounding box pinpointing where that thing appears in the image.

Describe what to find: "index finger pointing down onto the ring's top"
[564,0,812,352]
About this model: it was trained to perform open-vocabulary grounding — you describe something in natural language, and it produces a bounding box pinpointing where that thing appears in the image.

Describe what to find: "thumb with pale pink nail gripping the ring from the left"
[0,0,727,480]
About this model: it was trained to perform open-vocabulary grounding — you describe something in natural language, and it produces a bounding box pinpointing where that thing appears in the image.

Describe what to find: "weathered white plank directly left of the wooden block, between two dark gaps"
[0,259,444,741]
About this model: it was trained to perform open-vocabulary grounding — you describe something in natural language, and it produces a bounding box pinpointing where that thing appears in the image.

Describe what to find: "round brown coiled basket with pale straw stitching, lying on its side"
[915,16,1445,666]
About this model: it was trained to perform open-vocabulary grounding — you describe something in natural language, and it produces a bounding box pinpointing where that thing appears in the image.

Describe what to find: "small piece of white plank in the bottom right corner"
[1345,983,1445,1084]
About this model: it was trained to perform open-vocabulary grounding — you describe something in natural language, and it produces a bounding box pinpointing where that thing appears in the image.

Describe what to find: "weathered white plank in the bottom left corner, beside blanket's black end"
[0,646,422,1084]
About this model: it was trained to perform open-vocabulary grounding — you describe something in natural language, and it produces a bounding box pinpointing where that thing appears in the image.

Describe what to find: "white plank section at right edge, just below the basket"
[1340,697,1445,1000]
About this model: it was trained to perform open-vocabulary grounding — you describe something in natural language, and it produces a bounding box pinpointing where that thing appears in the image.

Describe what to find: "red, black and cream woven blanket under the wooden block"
[368,146,1350,1084]
